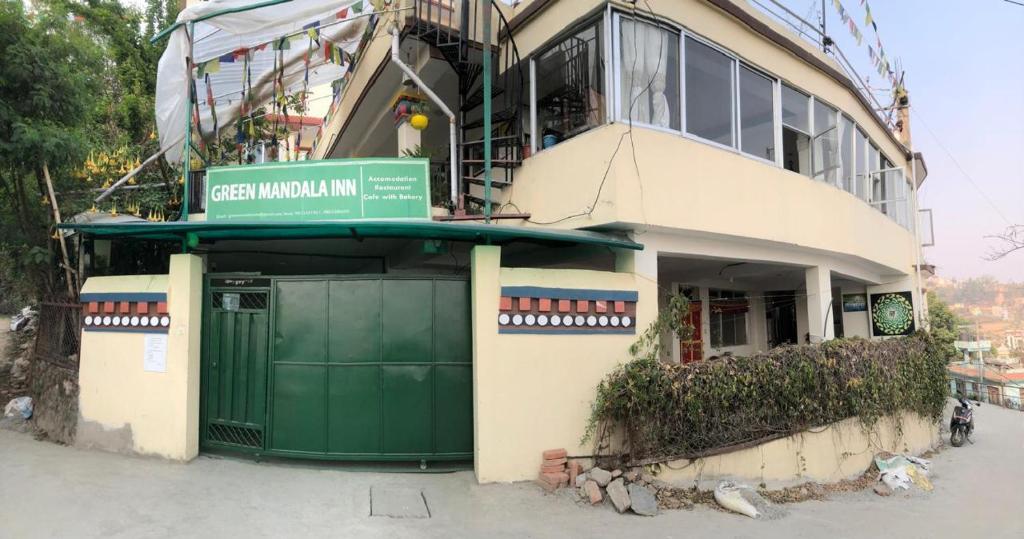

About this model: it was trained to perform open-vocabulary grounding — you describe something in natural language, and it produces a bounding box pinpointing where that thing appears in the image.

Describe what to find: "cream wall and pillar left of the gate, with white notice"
[77,254,203,460]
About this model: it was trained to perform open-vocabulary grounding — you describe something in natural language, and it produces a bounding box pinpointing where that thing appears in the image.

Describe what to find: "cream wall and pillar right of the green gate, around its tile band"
[472,246,657,483]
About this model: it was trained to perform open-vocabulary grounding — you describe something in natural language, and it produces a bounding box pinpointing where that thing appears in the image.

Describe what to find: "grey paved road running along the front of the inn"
[0,399,1024,539]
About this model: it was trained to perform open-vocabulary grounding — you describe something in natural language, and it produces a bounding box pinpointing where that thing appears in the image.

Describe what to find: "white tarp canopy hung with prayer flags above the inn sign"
[156,0,374,163]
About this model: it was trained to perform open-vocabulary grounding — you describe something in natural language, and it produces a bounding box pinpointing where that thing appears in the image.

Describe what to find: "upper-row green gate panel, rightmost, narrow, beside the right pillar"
[434,280,473,364]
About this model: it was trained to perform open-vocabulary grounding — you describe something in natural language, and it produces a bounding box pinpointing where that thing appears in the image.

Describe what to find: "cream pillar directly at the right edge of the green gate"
[469,245,504,483]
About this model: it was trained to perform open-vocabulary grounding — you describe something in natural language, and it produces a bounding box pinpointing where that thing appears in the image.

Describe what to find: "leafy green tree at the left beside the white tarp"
[0,0,180,307]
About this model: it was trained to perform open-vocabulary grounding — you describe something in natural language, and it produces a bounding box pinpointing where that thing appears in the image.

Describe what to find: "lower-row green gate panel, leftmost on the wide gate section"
[270,365,327,453]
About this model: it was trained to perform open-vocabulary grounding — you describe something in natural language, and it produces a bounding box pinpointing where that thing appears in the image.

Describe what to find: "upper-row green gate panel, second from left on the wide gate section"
[328,279,383,364]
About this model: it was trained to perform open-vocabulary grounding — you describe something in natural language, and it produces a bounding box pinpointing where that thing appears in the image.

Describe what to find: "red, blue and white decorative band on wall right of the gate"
[498,286,637,335]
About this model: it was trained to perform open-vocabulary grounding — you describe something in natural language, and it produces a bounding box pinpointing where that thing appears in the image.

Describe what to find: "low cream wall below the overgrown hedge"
[658,413,940,489]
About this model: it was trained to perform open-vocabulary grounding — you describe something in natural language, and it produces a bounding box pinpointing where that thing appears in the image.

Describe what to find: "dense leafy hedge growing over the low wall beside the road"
[588,332,948,460]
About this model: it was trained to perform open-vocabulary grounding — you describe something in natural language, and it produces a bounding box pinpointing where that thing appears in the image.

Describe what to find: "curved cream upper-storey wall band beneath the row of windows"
[500,124,915,274]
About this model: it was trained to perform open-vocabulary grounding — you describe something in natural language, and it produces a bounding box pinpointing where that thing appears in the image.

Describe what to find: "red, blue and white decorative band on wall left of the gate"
[81,293,171,333]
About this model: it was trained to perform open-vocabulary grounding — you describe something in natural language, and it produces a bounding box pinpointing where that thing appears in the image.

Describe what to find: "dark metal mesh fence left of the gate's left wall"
[33,301,82,371]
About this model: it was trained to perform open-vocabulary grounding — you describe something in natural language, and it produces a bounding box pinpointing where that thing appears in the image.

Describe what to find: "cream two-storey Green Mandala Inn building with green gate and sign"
[61,0,927,482]
